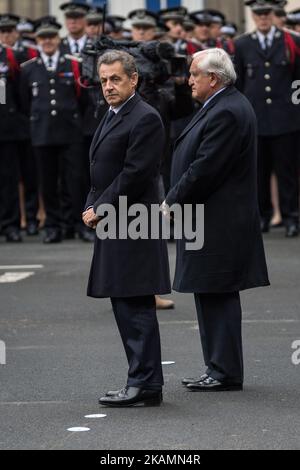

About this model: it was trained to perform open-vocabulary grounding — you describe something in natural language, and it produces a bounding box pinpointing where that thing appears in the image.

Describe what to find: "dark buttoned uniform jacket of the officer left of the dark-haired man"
[21,56,83,147]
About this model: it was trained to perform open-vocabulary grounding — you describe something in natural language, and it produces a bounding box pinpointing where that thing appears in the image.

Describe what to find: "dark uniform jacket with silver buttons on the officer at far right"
[235,29,300,136]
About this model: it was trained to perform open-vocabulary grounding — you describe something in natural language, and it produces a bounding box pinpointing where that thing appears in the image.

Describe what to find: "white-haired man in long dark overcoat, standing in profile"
[164,49,269,391]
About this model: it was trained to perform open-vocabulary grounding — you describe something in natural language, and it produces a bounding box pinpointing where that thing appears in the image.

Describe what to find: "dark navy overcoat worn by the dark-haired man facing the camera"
[86,95,171,297]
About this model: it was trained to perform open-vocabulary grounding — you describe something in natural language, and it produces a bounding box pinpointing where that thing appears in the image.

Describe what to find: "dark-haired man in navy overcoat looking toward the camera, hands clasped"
[83,51,171,407]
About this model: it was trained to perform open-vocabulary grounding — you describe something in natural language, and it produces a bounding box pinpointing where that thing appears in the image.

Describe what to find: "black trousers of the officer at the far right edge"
[258,133,299,225]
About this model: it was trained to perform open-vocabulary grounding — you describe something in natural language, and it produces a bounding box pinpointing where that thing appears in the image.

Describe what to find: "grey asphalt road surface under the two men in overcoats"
[0,229,300,450]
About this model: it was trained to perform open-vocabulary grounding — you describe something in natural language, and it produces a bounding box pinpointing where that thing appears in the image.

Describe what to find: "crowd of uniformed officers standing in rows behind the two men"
[0,0,300,248]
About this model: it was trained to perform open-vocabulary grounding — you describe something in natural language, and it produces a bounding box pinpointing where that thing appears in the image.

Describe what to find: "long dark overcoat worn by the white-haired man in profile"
[167,87,269,293]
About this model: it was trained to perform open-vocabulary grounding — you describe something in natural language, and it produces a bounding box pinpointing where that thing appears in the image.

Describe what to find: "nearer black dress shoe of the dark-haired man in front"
[99,387,163,408]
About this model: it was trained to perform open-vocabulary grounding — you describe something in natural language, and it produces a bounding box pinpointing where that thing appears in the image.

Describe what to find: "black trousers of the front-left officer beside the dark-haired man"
[35,144,84,230]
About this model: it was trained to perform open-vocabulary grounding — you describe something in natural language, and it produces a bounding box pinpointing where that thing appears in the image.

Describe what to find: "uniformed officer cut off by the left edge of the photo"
[0,15,28,242]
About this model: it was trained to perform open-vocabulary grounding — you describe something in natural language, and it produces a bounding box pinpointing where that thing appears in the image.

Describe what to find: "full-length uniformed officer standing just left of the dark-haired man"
[21,16,86,244]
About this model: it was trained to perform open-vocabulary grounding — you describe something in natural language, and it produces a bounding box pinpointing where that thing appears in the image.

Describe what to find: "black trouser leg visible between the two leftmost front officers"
[18,140,39,223]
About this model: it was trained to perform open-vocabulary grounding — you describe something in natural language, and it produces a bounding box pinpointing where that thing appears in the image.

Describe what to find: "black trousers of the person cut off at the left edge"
[0,142,20,234]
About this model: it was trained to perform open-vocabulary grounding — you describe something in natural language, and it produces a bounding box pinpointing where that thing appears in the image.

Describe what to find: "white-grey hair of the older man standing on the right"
[193,48,237,86]
